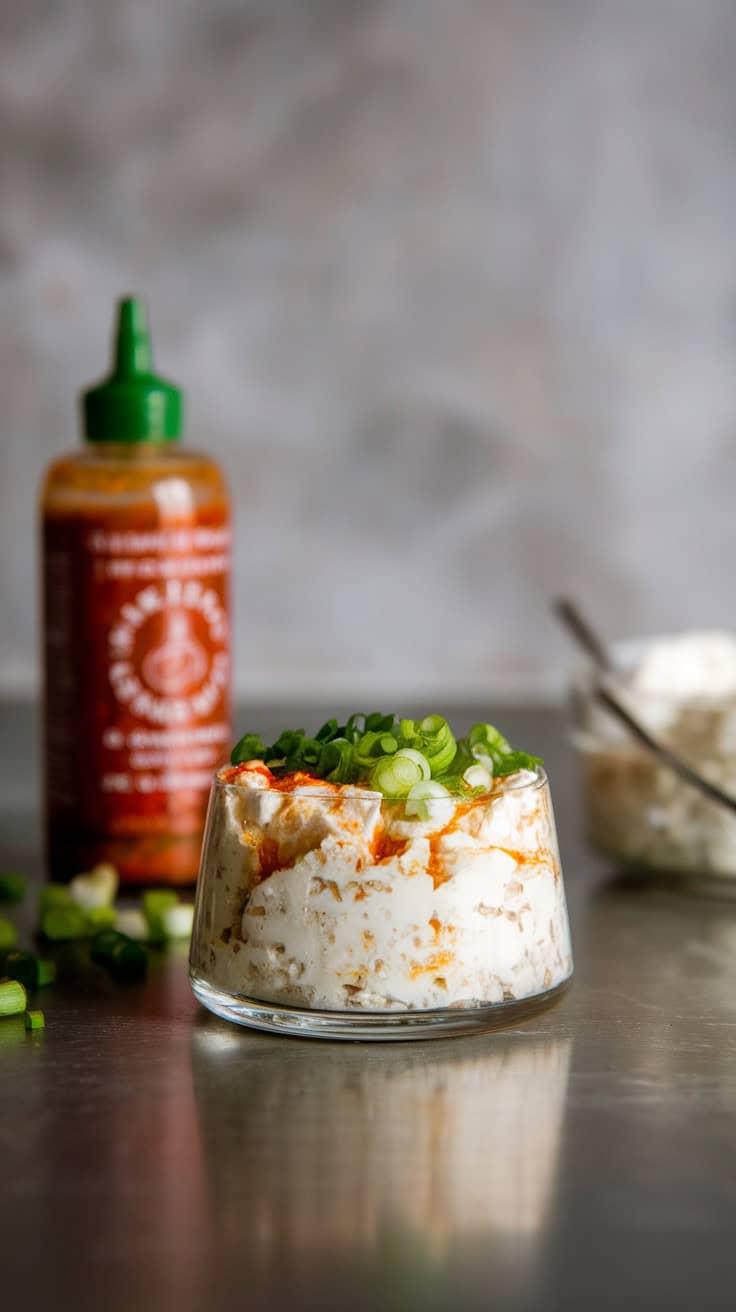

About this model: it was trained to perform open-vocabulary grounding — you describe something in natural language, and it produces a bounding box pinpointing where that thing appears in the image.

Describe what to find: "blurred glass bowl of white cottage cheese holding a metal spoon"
[572,631,736,890]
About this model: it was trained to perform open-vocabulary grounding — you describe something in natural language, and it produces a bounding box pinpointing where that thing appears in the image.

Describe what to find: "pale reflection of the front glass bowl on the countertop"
[192,1022,571,1260]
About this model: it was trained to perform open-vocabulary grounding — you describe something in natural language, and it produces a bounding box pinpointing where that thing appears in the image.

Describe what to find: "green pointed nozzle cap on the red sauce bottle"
[81,297,184,442]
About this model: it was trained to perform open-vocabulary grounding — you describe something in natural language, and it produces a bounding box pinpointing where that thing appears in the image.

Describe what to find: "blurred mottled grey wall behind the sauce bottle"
[0,0,736,698]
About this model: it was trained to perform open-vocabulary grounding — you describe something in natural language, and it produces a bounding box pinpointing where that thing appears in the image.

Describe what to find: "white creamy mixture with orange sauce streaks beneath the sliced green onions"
[192,771,572,1010]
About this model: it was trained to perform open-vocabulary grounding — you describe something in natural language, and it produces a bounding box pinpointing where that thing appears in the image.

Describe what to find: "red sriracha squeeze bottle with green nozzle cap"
[42,298,231,884]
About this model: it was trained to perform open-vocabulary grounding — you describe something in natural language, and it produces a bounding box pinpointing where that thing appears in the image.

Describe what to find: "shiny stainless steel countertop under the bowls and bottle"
[0,708,736,1312]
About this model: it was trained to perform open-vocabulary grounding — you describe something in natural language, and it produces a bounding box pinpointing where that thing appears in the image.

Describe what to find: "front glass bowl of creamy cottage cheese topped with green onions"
[190,716,572,1039]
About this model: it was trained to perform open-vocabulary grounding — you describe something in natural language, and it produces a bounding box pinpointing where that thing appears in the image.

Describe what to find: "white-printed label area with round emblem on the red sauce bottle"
[45,510,231,836]
